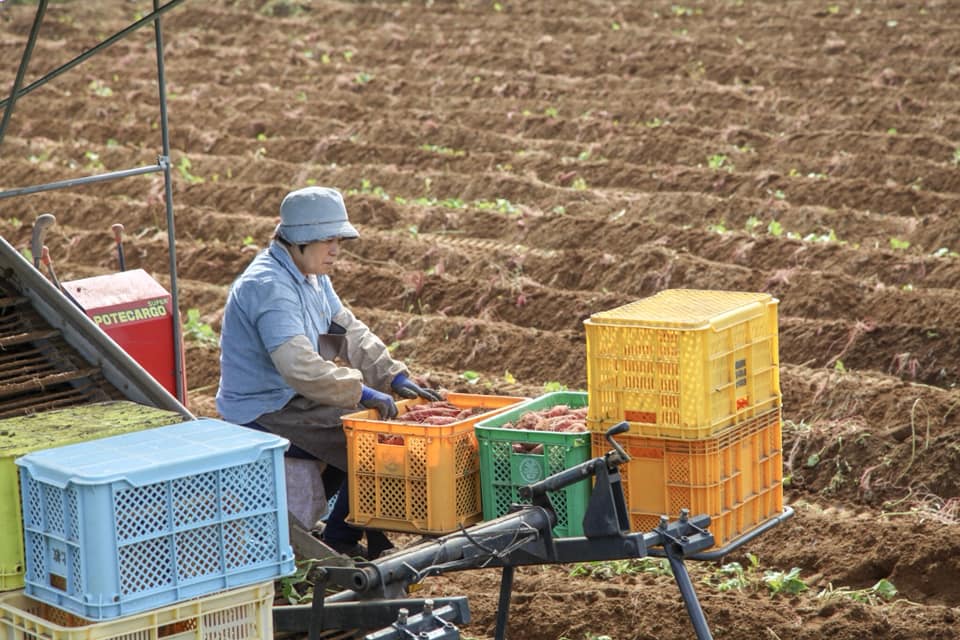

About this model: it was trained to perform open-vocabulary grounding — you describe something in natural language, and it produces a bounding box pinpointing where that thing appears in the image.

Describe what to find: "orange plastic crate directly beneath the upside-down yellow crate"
[592,408,783,547]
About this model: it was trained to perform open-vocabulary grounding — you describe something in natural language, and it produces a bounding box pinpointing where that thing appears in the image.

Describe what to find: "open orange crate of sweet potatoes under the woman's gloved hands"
[343,393,527,535]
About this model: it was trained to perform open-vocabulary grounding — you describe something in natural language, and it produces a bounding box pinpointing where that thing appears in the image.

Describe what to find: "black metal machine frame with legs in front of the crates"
[274,422,793,640]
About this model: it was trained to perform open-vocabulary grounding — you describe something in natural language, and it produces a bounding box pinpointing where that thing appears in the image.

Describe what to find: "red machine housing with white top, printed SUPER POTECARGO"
[63,269,186,403]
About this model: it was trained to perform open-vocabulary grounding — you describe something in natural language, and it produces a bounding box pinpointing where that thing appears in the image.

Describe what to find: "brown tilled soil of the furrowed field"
[0,0,960,640]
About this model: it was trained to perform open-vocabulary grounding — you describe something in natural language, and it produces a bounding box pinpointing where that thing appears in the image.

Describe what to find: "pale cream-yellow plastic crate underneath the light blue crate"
[0,582,274,640]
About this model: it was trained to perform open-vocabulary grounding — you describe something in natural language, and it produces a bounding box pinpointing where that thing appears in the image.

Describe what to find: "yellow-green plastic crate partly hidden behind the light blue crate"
[0,400,184,591]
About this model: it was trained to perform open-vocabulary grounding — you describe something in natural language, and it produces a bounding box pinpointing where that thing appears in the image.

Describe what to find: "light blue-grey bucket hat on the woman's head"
[277,187,360,244]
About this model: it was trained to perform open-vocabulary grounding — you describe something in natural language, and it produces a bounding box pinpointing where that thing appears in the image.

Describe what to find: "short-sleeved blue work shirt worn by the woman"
[217,241,343,424]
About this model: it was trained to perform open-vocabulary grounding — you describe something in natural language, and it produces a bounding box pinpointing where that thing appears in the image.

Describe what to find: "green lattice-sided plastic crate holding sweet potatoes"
[475,391,592,538]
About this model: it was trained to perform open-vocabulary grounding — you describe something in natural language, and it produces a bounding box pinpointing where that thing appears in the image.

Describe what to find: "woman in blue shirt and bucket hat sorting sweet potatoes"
[217,187,440,559]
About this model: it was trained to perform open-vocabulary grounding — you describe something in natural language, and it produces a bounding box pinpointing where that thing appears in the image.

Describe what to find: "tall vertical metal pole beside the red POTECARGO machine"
[153,0,187,402]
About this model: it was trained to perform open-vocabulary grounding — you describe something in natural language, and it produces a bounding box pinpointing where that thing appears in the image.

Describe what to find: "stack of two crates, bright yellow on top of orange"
[584,289,783,546]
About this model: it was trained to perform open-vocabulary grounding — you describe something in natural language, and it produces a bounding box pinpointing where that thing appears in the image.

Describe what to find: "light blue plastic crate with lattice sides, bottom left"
[16,419,294,620]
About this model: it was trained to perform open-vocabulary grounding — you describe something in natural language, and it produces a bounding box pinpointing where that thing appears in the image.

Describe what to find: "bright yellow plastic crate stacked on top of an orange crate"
[584,289,781,439]
